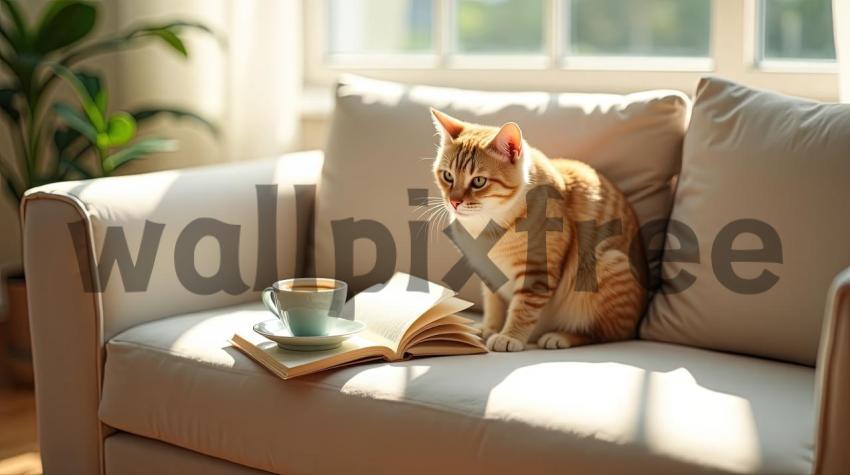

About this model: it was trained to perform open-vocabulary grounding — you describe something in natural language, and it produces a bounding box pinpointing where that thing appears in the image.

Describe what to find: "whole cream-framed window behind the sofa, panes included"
[303,0,838,101]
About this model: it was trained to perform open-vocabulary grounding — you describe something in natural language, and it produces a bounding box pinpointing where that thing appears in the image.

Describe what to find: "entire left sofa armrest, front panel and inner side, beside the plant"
[21,152,323,473]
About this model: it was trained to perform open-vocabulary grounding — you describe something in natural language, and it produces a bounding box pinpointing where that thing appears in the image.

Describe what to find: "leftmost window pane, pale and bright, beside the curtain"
[324,0,434,54]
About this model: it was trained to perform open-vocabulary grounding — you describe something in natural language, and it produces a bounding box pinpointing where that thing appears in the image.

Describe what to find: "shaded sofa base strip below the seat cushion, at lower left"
[104,432,268,475]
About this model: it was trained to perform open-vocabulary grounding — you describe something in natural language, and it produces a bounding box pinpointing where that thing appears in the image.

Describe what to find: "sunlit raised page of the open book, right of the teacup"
[343,272,455,347]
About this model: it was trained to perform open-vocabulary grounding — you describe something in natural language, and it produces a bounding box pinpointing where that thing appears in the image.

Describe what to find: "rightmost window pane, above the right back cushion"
[761,0,835,59]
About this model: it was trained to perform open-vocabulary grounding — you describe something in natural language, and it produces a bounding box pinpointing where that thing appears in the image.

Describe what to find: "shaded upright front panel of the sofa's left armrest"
[23,197,103,474]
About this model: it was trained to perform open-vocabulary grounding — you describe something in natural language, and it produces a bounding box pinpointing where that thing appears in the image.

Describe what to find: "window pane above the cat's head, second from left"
[454,0,544,54]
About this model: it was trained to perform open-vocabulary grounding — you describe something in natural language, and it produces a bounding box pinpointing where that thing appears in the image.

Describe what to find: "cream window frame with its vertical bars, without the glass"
[304,0,838,102]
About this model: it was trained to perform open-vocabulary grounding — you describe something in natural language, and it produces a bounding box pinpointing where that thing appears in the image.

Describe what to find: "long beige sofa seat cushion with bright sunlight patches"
[100,304,814,474]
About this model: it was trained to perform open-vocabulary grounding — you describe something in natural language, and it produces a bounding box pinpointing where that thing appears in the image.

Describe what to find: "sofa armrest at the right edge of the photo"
[815,268,850,475]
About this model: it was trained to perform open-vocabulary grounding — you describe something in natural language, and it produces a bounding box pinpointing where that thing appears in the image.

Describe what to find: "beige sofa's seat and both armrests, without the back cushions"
[22,76,850,474]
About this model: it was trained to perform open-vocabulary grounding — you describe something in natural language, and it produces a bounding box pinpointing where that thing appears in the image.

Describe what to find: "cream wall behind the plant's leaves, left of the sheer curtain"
[110,0,229,174]
